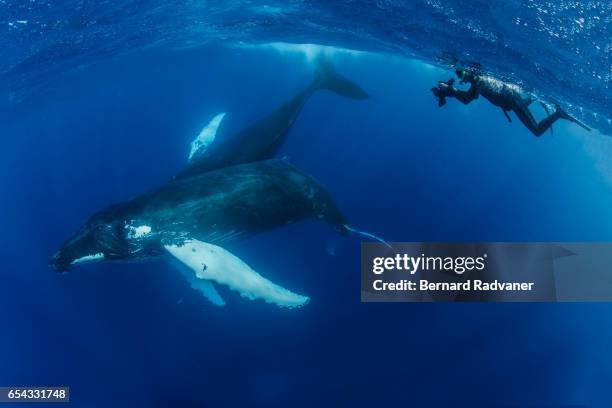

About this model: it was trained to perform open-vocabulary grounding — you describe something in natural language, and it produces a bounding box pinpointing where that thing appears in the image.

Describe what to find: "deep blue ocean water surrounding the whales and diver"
[0,1,612,407]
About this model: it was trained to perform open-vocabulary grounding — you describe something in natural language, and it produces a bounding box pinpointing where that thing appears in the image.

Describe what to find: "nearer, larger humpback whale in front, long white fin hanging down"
[50,160,350,307]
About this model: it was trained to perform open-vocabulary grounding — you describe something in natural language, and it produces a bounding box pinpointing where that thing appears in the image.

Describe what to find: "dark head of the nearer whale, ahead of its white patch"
[49,215,125,272]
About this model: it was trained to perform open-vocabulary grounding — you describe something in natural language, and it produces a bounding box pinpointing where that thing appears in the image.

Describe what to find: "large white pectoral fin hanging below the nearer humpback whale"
[165,240,309,307]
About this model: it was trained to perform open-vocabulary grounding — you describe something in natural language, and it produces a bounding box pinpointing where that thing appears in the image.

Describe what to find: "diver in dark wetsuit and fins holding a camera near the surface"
[431,69,591,136]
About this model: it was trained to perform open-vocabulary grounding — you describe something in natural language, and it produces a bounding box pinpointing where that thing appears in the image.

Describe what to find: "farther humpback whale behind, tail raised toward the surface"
[176,60,369,178]
